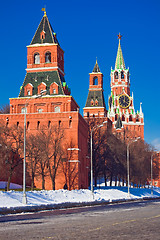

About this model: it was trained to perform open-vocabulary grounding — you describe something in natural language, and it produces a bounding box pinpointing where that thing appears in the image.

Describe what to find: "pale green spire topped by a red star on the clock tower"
[115,33,126,69]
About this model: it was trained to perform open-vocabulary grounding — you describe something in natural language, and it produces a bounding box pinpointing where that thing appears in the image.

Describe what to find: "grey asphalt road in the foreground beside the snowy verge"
[0,200,160,240]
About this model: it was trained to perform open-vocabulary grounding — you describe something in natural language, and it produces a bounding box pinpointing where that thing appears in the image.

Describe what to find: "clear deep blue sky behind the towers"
[0,0,160,148]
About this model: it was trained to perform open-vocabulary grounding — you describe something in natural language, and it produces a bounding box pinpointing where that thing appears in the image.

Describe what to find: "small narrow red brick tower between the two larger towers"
[83,60,107,118]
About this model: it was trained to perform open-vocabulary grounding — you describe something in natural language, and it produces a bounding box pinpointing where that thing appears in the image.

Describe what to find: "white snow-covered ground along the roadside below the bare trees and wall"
[0,184,160,208]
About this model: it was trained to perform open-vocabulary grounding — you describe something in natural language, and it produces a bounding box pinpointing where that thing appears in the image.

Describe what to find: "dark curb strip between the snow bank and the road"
[0,197,160,215]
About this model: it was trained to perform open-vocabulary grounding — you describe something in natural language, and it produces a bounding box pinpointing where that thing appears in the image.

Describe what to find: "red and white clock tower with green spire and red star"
[108,34,144,141]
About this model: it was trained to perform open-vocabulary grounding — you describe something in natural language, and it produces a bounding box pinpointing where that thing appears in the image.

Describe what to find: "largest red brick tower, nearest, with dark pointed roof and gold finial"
[0,9,88,189]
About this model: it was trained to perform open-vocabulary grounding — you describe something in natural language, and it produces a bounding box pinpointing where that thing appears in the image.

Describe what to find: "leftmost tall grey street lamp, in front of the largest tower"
[22,90,47,204]
